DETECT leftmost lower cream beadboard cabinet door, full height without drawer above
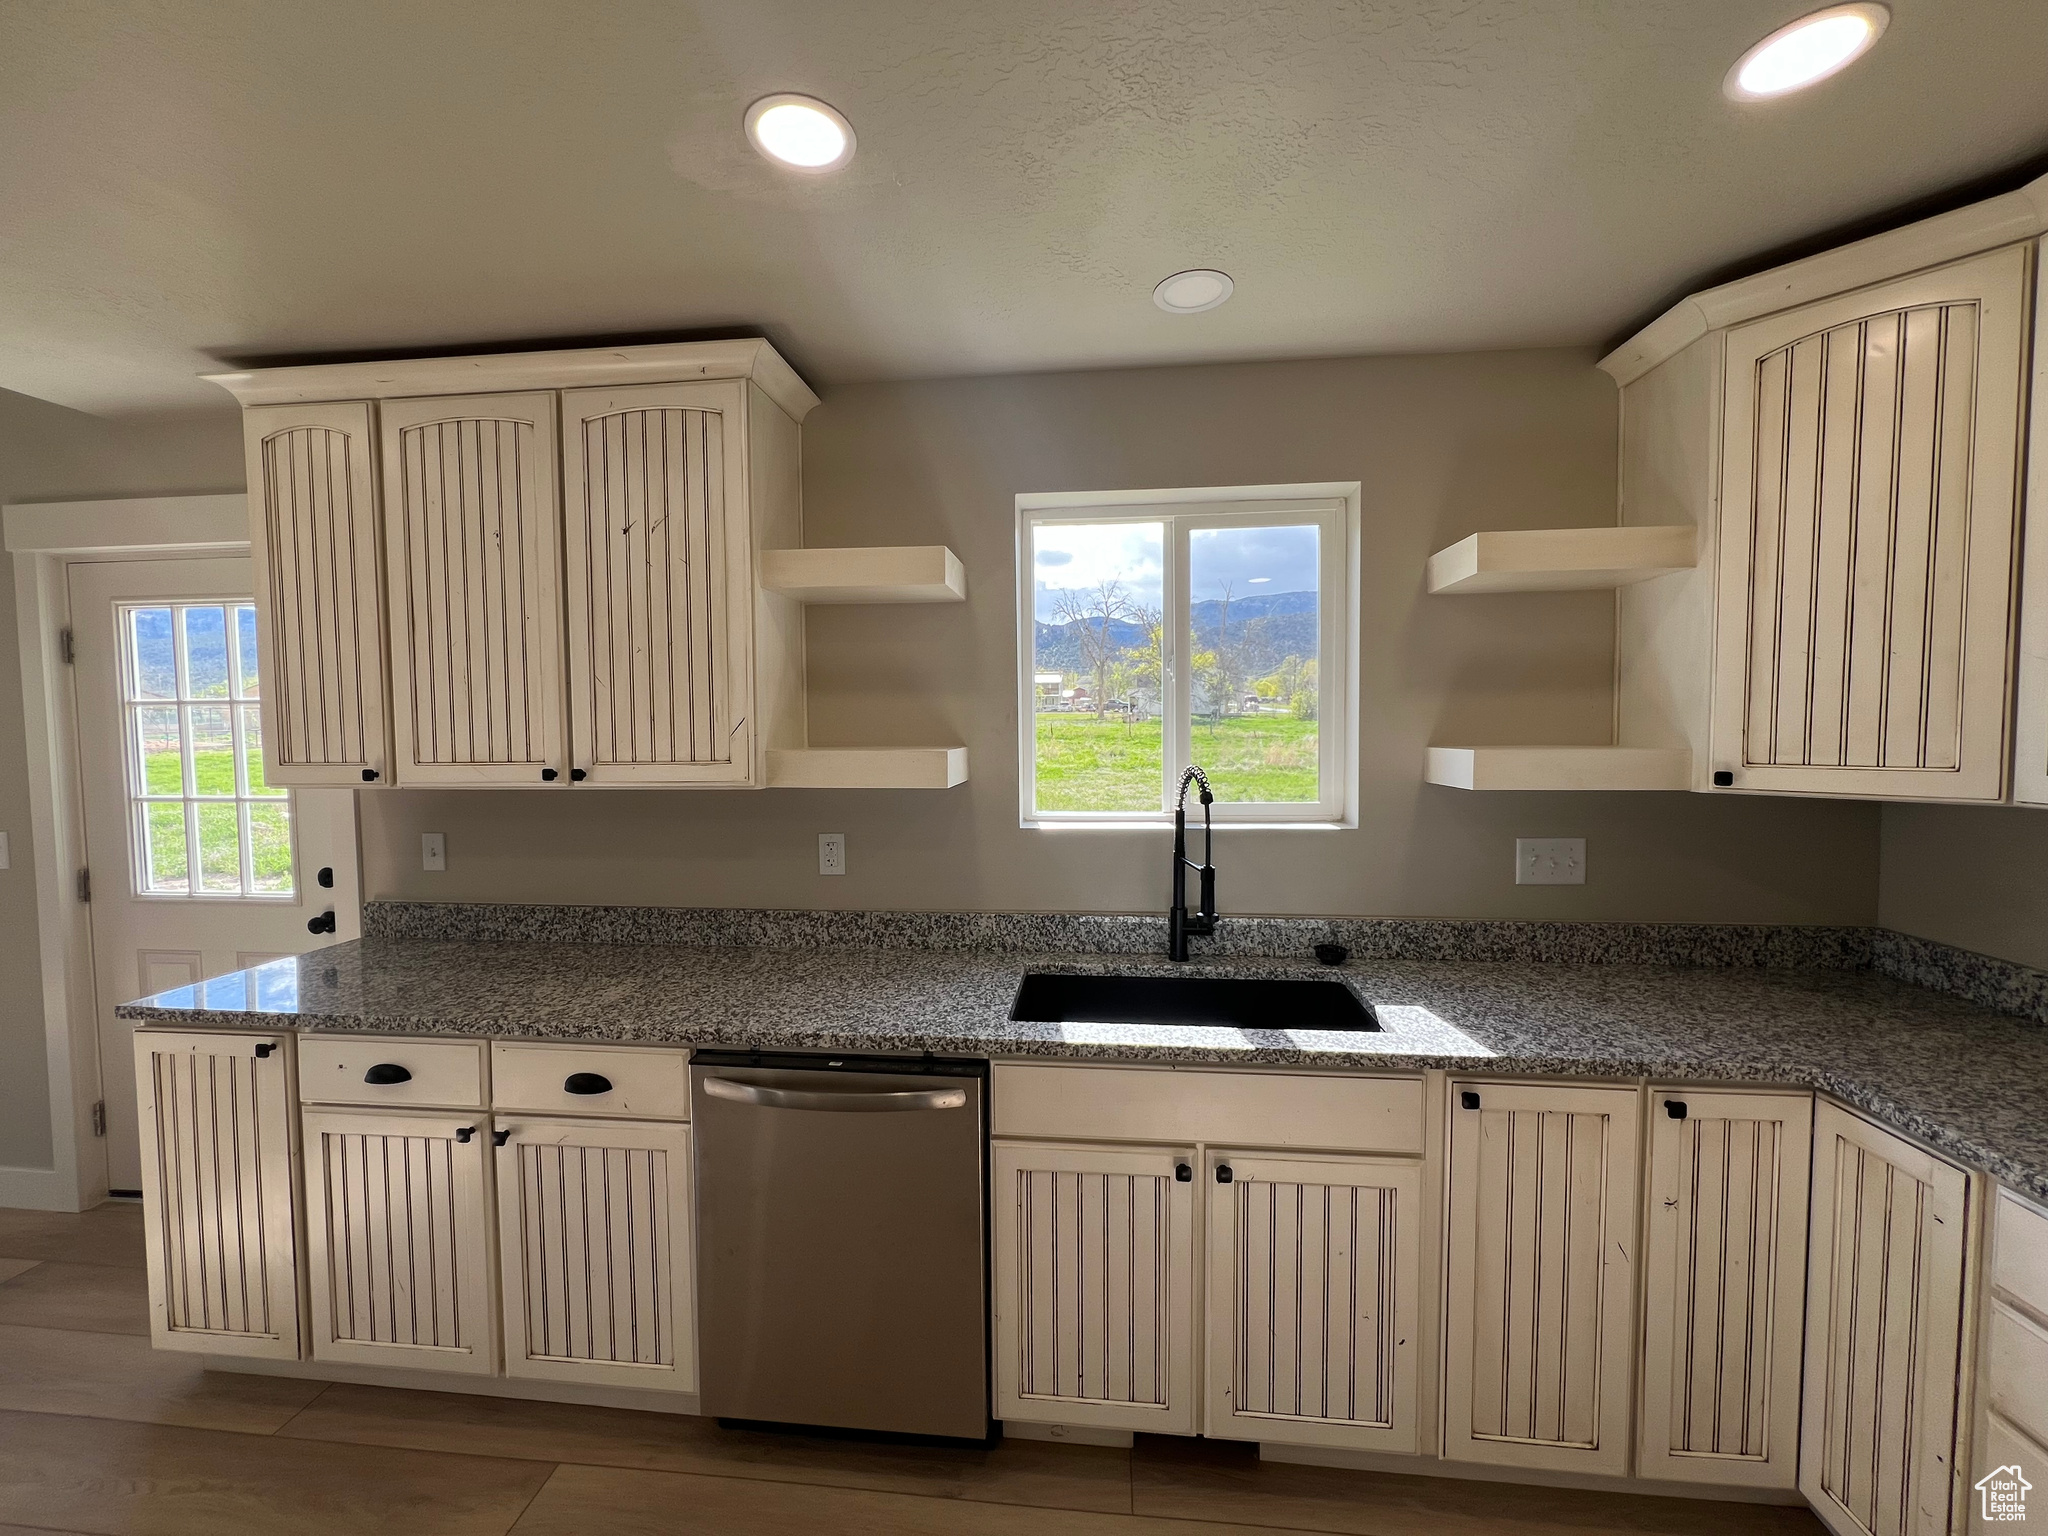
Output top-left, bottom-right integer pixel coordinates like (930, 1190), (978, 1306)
(135, 1030), (299, 1360)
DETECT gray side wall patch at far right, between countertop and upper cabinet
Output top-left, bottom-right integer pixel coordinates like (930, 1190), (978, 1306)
(1878, 805), (2048, 971)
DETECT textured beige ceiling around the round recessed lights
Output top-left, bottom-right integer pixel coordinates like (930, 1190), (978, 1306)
(0, 0), (2048, 412)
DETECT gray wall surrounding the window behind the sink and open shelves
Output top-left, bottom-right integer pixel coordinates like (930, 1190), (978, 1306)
(360, 352), (1878, 924)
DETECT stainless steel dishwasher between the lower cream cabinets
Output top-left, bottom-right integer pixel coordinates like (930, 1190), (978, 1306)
(690, 1051), (989, 1440)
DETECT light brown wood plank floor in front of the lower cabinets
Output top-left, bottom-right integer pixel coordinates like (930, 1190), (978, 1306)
(0, 1206), (1821, 1536)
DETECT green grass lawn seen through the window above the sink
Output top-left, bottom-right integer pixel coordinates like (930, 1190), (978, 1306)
(1038, 715), (1317, 811)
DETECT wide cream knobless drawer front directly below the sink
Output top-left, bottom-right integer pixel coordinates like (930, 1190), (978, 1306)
(989, 1063), (1423, 1153)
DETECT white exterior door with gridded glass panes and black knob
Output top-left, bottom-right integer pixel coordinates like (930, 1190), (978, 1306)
(70, 557), (356, 1190)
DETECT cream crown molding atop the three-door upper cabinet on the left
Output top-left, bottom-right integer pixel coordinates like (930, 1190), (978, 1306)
(201, 340), (817, 422)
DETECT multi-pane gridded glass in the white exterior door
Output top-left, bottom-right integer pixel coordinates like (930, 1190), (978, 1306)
(117, 602), (297, 901)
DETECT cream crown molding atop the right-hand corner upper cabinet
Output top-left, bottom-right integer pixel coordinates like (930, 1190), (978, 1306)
(1599, 165), (2048, 385)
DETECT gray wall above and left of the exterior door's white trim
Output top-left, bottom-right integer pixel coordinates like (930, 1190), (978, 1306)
(0, 391), (242, 1167)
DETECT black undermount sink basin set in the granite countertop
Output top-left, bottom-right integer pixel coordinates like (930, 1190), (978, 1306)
(1010, 971), (1380, 1030)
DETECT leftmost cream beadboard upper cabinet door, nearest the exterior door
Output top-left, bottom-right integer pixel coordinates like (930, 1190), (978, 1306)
(242, 401), (389, 784)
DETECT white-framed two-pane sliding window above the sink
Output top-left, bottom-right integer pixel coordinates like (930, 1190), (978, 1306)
(1018, 485), (1358, 827)
